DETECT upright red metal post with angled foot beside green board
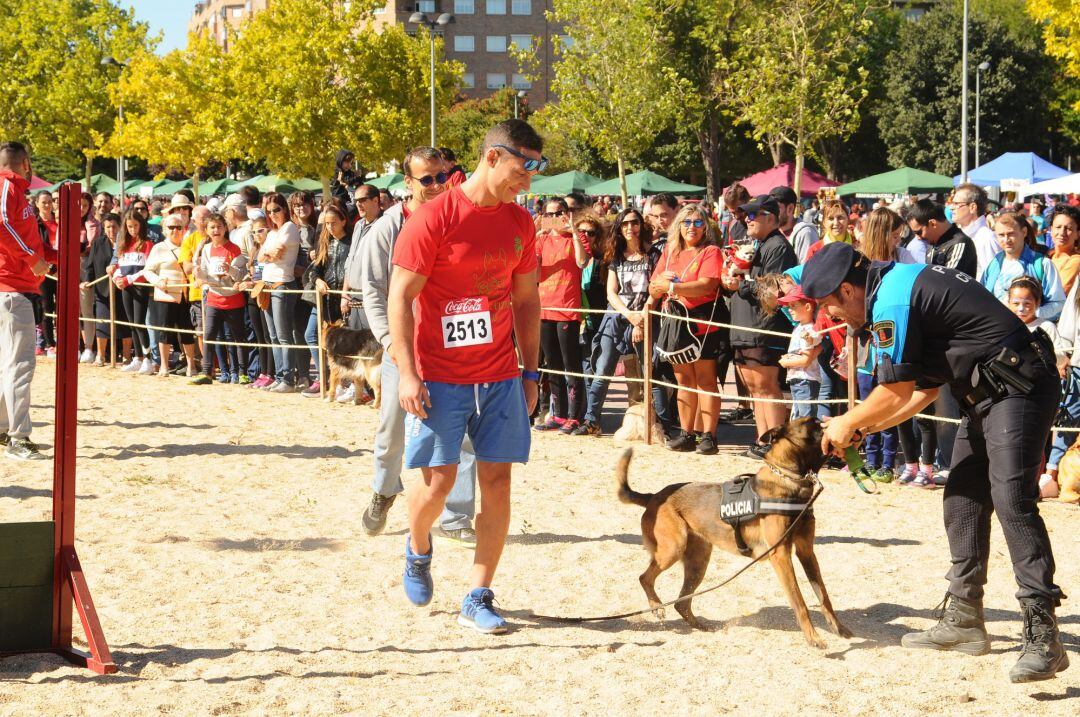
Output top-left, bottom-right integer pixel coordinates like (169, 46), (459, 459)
(45, 184), (117, 675)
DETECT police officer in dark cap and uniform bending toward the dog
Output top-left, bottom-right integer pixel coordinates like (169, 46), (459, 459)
(802, 242), (1069, 682)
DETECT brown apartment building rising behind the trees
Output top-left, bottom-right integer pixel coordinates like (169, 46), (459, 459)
(188, 0), (562, 109)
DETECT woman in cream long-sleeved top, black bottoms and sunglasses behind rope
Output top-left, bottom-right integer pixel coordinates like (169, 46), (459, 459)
(143, 213), (195, 377)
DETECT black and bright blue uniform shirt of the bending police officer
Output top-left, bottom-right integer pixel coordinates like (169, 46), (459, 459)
(866, 262), (1030, 397)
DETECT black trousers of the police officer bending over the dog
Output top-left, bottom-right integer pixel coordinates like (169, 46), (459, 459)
(945, 371), (1062, 604)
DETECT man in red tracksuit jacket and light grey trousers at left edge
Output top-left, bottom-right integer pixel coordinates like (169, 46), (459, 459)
(0, 141), (54, 460)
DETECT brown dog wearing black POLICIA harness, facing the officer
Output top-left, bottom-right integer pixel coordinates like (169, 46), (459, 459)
(617, 418), (851, 648)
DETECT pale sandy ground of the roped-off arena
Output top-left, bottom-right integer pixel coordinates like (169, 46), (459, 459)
(0, 363), (1080, 715)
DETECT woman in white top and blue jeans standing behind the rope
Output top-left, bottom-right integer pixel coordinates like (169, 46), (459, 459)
(257, 192), (309, 393)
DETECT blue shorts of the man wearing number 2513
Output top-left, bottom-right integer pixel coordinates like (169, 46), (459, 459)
(405, 378), (532, 469)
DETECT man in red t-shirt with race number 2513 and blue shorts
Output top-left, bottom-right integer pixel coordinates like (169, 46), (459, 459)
(388, 120), (546, 633)
